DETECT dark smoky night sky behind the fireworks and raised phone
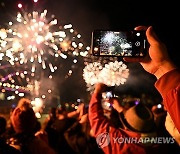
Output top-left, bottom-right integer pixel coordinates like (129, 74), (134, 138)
(0, 0), (180, 104)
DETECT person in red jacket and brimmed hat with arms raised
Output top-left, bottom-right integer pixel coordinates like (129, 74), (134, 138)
(89, 83), (179, 154)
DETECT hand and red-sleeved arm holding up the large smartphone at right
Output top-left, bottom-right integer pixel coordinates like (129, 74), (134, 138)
(124, 26), (180, 143)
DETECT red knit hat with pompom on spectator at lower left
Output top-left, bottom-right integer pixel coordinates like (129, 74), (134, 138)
(11, 106), (37, 133)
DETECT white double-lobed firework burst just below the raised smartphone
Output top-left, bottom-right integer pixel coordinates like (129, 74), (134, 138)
(83, 61), (129, 91)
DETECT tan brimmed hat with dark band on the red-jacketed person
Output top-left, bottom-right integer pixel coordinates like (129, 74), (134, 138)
(120, 103), (155, 133)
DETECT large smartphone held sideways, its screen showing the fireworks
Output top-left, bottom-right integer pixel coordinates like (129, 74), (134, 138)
(91, 30), (148, 57)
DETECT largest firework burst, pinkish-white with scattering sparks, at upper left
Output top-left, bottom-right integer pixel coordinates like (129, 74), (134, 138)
(0, 10), (89, 72)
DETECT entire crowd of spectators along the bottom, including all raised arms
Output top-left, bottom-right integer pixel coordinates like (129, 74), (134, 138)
(0, 26), (180, 154)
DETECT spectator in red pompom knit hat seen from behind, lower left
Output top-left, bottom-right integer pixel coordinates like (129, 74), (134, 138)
(9, 101), (55, 154)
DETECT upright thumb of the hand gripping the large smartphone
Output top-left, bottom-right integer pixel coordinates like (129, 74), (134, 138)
(146, 26), (160, 46)
